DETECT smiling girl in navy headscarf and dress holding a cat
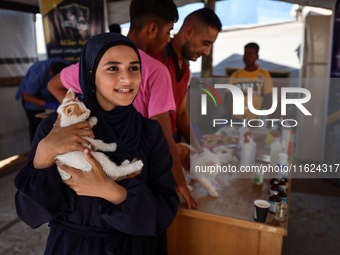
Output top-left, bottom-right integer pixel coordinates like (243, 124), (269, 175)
(15, 33), (179, 255)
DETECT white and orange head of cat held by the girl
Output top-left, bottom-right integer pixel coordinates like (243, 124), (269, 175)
(57, 90), (91, 127)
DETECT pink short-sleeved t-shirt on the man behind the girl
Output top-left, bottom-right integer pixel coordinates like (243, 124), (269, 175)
(60, 50), (176, 118)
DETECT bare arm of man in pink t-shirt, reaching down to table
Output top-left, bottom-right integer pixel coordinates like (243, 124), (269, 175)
(151, 112), (198, 210)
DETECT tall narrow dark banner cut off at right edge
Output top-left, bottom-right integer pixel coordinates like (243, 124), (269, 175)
(323, 0), (340, 164)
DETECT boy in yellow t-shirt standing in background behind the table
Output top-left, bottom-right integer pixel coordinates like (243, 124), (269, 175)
(225, 42), (273, 120)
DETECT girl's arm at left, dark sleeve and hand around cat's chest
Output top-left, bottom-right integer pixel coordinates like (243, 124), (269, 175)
(14, 114), (93, 228)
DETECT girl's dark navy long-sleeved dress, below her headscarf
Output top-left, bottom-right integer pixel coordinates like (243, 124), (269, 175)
(14, 114), (179, 255)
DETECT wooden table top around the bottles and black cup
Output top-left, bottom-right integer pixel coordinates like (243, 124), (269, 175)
(179, 130), (291, 236)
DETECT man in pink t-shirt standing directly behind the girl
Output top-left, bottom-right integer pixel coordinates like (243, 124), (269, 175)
(48, 0), (198, 209)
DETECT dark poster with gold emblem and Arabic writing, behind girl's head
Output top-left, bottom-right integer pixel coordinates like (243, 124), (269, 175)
(40, 0), (105, 63)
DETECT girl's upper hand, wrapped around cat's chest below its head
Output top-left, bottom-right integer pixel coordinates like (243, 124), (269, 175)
(33, 114), (94, 169)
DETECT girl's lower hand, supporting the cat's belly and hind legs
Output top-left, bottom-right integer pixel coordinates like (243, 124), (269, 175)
(56, 149), (127, 204)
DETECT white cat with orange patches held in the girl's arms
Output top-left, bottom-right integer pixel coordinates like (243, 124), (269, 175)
(56, 89), (143, 180)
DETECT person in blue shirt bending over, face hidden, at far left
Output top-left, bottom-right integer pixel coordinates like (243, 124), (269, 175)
(15, 58), (70, 143)
